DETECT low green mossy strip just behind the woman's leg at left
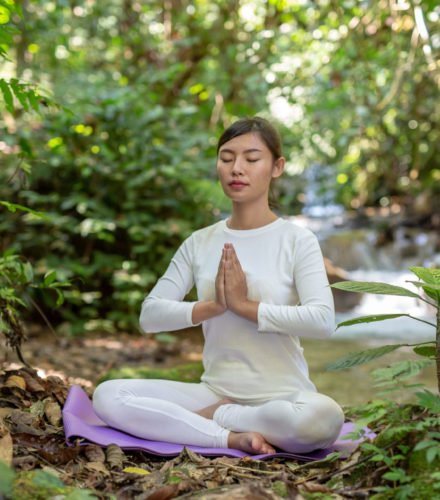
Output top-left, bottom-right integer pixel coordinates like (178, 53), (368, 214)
(98, 361), (203, 383)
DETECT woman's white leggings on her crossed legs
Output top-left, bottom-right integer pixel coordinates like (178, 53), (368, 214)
(93, 379), (344, 453)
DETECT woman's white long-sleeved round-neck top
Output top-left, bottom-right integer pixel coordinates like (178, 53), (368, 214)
(140, 218), (335, 404)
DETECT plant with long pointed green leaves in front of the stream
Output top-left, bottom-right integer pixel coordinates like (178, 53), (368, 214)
(326, 267), (440, 392)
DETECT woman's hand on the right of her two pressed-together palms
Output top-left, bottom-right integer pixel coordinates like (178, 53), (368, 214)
(223, 243), (247, 314)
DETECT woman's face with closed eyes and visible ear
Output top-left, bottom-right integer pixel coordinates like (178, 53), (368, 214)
(217, 132), (285, 203)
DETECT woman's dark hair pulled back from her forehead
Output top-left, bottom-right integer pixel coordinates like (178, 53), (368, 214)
(217, 116), (282, 160)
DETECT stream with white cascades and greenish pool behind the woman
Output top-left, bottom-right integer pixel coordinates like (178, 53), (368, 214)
(289, 187), (440, 404)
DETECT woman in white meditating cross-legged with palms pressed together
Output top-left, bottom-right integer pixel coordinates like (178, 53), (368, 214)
(93, 117), (344, 454)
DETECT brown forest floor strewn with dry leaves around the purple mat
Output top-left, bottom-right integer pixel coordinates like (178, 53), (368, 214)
(0, 332), (438, 500)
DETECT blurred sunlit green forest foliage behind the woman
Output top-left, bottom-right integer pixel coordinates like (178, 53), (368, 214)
(0, 0), (440, 333)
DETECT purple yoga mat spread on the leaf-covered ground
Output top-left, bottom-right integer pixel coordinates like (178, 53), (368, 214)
(63, 385), (375, 461)
